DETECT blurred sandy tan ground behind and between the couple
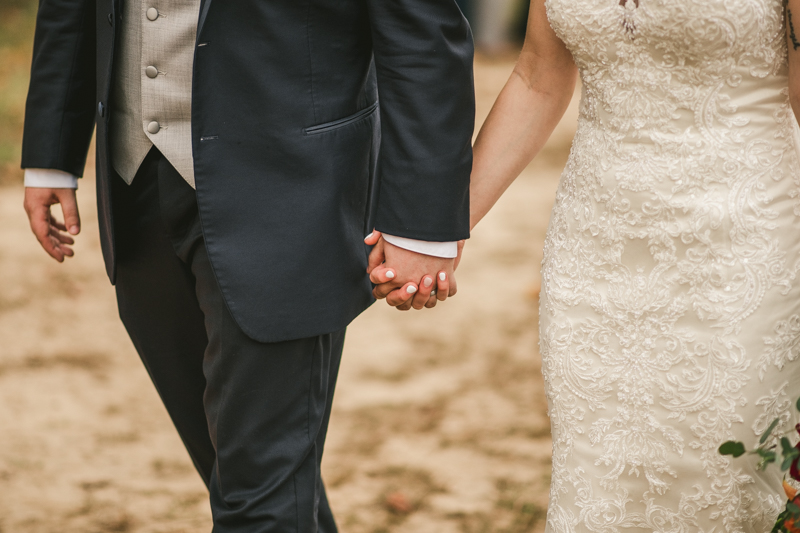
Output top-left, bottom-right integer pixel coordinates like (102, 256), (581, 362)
(0, 60), (576, 533)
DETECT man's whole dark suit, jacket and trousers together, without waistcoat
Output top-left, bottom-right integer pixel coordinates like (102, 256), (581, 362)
(22, 0), (474, 533)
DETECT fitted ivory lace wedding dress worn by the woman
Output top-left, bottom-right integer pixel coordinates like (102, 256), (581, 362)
(540, 0), (800, 533)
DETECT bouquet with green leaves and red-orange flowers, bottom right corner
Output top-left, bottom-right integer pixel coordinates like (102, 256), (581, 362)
(719, 398), (800, 533)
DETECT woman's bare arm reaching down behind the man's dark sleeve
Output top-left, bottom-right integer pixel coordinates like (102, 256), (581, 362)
(470, 0), (576, 227)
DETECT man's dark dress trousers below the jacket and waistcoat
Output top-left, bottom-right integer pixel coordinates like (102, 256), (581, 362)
(111, 148), (344, 533)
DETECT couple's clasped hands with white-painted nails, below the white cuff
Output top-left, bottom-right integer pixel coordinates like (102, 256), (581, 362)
(364, 231), (464, 311)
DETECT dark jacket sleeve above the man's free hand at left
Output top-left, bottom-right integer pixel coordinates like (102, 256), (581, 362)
(22, 0), (97, 176)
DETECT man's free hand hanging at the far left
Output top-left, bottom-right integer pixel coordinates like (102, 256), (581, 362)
(24, 187), (81, 263)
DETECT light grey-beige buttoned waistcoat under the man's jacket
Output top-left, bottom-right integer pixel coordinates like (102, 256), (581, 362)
(109, 0), (200, 187)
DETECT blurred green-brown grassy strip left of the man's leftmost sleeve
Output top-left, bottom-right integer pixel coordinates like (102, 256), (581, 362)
(0, 0), (38, 183)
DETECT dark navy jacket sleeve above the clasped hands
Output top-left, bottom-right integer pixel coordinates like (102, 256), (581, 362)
(367, 0), (475, 241)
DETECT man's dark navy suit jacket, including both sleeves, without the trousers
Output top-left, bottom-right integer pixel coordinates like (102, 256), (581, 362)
(22, 0), (474, 342)
